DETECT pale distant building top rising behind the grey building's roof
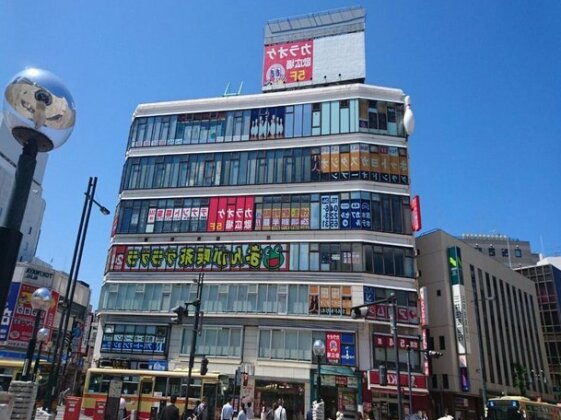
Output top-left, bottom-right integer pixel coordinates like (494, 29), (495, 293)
(459, 234), (540, 269)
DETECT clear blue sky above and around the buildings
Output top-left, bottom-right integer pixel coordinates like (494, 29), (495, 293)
(0, 0), (561, 307)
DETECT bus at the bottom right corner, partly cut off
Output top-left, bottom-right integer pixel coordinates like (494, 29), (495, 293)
(486, 396), (561, 420)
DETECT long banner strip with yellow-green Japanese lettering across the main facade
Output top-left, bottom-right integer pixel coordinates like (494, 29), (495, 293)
(108, 243), (290, 271)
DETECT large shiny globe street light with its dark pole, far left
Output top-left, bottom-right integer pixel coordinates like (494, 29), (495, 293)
(0, 68), (76, 316)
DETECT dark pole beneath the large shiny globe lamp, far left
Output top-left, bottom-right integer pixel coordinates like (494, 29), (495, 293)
(0, 139), (38, 313)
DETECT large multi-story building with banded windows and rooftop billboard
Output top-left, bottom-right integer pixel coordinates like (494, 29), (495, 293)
(94, 9), (422, 419)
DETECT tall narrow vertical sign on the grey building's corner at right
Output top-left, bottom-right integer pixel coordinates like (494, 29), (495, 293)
(448, 246), (470, 392)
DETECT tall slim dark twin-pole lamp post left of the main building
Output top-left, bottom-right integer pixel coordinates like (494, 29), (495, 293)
(43, 177), (110, 412)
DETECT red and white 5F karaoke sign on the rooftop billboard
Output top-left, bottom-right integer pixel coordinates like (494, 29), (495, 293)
(263, 40), (314, 87)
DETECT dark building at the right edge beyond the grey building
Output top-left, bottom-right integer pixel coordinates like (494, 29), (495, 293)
(516, 258), (561, 400)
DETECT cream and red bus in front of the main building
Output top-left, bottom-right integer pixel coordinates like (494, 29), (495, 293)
(82, 368), (228, 420)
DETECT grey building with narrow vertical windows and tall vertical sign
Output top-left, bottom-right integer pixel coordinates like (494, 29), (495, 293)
(416, 230), (553, 420)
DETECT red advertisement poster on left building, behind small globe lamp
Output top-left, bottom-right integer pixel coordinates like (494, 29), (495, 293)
(8, 283), (59, 348)
